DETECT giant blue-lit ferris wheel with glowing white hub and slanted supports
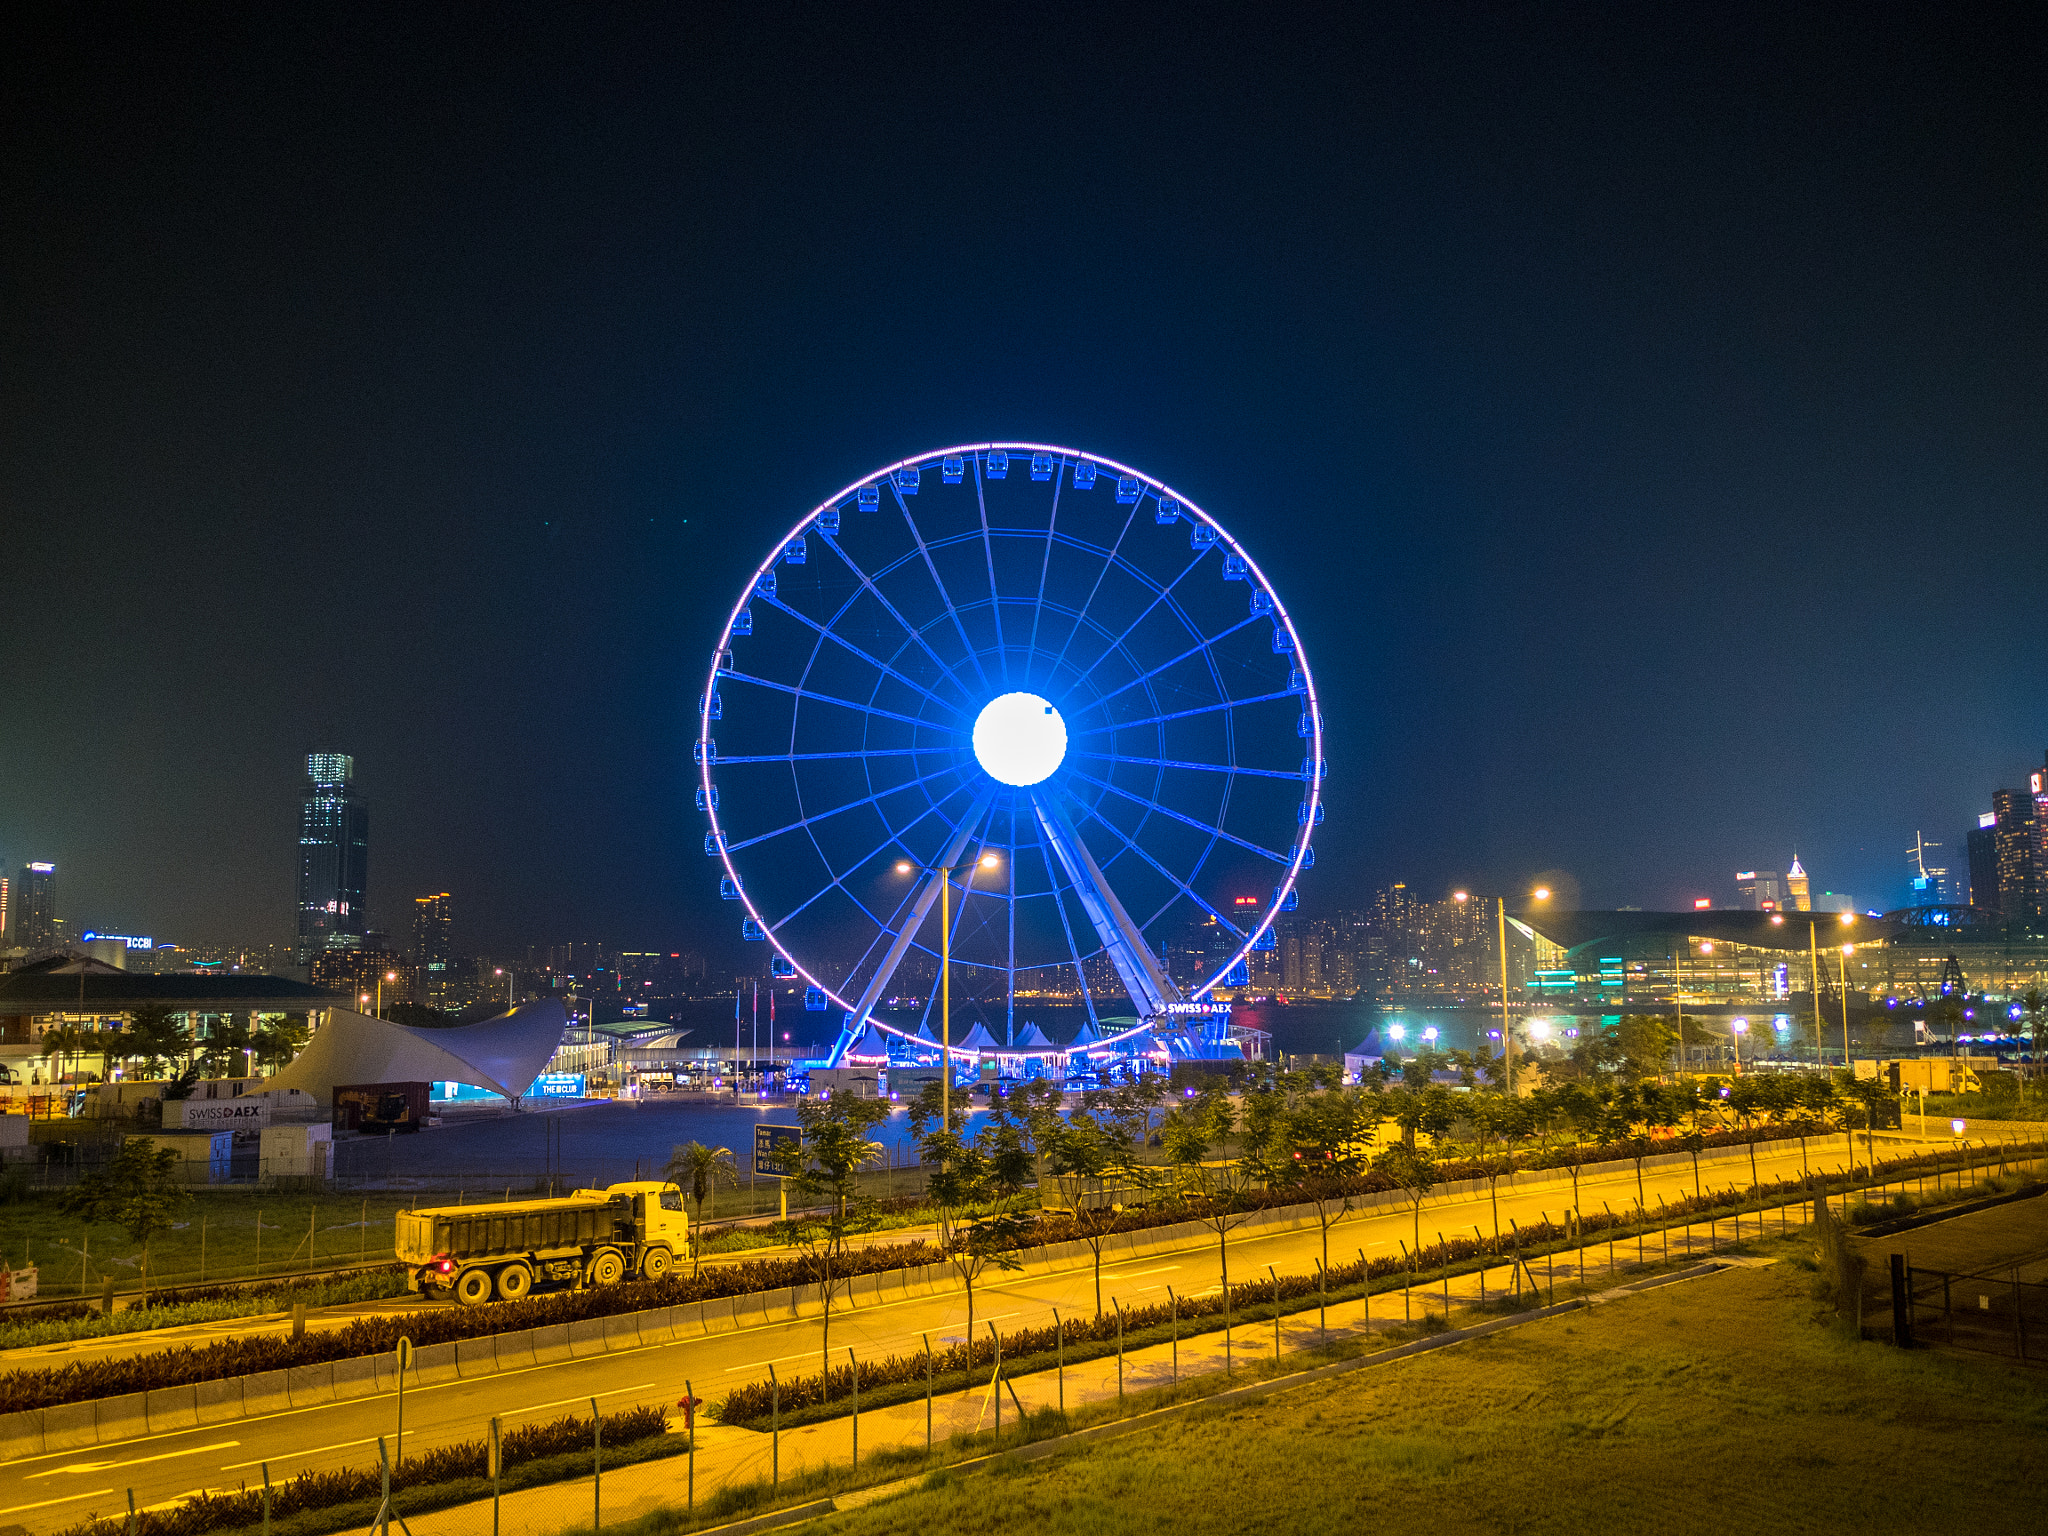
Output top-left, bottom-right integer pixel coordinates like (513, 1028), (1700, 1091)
(694, 442), (1327, 1055)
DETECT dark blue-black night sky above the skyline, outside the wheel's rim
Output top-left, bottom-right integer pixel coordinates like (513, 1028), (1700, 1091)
(0, 4), (2048, 950)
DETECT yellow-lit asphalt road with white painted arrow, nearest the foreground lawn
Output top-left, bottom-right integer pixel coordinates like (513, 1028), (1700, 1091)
(0, 1137), (1966, 1532)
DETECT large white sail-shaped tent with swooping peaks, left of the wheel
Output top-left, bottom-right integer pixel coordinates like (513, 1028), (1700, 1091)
(264, 999), (569, 1108)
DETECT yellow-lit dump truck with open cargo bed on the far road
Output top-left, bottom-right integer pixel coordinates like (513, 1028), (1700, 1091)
(397, 1180), (690, 1307)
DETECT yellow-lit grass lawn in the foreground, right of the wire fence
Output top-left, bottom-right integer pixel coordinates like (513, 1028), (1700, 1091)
(798, 1264), (2048, 1536)
